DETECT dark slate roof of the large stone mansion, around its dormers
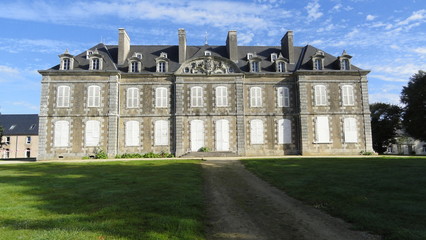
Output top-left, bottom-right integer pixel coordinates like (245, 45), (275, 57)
(49, 43), (361, 72)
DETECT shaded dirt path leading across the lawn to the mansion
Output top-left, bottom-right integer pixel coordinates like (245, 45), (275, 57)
(203, 160), (380, 240)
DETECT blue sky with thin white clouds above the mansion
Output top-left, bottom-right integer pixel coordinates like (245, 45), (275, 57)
(0, 0), (426, 114)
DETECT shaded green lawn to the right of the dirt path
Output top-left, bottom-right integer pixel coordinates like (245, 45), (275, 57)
(243, 157), (426, 240)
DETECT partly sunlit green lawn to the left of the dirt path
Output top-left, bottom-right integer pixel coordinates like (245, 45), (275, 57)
(0, 160), (204, 240)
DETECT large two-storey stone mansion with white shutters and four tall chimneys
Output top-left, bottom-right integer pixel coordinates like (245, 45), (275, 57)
(39, 29), (372, 159)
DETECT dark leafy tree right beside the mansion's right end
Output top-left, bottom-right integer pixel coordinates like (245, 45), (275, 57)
(370, 103), (402, 154)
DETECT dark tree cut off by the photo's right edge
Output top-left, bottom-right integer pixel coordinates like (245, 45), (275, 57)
(401, 71), (426, 141)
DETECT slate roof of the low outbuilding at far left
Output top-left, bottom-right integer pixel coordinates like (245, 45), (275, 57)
(0, 114), (38, 136)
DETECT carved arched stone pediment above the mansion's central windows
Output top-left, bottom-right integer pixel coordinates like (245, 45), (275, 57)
(176, 56), (240, 75)
